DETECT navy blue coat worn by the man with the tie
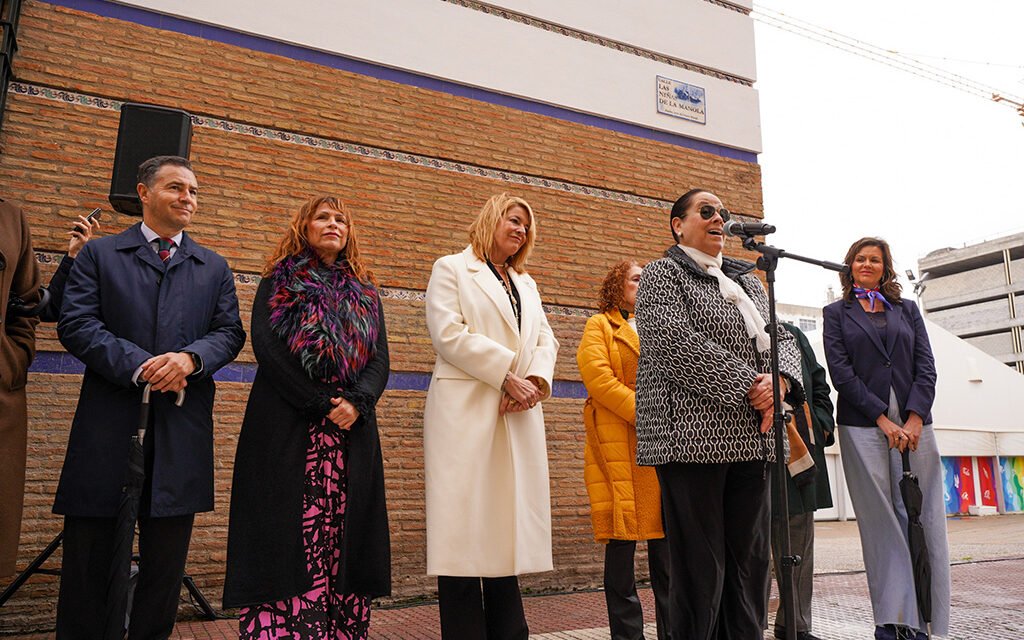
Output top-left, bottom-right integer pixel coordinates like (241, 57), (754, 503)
(53, 224), (246, 517)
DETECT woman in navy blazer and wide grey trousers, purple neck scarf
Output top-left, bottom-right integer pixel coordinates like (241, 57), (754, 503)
(824, 238), (949, 640)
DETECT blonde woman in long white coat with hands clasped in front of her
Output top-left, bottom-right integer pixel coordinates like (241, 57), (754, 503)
(423, 194), (558, 640)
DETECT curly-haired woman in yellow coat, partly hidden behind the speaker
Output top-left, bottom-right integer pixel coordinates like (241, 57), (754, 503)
(577, 261), (669, 640)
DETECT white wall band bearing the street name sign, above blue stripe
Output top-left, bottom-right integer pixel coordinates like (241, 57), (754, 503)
(116, 0), (761, 153)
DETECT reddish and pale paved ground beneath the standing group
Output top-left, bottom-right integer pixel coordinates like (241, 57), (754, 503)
(5, 515), (1024, 640)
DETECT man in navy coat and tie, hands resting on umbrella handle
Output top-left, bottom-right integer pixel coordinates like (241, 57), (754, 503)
(53, 156), (246, 640)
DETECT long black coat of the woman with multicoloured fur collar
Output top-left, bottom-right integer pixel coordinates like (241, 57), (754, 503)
(223, 278), (391, 608)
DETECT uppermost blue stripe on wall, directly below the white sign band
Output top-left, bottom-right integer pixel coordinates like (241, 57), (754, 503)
(37, 0), (758, 164)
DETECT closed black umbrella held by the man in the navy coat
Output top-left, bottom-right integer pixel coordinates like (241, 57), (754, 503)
(103, 384), (185, 640)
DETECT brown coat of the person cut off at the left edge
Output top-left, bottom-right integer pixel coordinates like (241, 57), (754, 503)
(0, 200), (39, 578)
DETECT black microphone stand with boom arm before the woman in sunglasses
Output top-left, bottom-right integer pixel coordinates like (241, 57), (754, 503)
(736, 232), (847, 640)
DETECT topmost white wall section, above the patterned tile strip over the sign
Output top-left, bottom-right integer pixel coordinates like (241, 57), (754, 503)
(488, 0), (757, 82)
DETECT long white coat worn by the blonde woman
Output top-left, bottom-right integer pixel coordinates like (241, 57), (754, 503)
(423, 247), (558, 578)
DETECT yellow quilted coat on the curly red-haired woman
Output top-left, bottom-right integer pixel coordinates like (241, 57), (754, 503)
(577, 309), (665, 542)
